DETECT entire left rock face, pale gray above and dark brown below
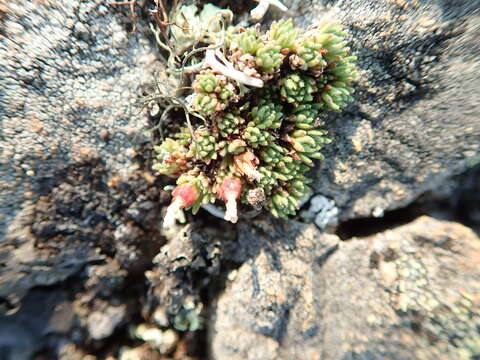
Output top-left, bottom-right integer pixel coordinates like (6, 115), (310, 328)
(0, 0), (168, 360)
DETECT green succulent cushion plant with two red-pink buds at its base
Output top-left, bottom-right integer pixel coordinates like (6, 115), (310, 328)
(154, 19), (357, 221)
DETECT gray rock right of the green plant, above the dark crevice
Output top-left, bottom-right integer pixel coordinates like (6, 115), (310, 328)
(298, 0), (480, 219)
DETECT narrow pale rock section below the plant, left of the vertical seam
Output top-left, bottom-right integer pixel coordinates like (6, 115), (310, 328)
(210, 221), (339, 360)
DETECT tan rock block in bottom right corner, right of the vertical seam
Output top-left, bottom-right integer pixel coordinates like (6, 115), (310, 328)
(321, 217), (480, 359)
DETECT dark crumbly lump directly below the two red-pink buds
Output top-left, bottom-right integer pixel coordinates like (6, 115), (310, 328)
(146, 223), (237, 328)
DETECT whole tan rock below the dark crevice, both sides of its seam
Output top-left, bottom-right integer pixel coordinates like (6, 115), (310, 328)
(210, 217), (480, 360)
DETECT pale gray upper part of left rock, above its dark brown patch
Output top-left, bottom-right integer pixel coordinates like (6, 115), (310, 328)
(0, 0), (156, 241)
